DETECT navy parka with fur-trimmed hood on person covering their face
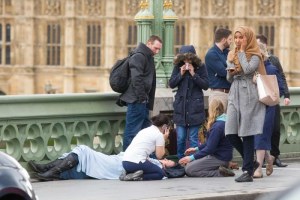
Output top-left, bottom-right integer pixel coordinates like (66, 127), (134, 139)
(169, 45), (208, 126)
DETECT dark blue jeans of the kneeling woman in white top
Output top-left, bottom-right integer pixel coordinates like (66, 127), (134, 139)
(122, 160), (165, 180)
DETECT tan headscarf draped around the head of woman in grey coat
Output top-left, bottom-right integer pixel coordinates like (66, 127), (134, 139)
(231, 26), (266, 75)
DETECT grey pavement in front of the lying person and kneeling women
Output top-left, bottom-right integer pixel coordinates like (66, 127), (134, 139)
(33, 161), (300, 200)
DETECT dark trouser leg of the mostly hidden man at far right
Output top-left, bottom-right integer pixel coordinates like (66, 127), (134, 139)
(271, 105), (280, 158)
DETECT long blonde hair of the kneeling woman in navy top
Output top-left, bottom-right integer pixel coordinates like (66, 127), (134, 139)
(206, 99), (225, 130)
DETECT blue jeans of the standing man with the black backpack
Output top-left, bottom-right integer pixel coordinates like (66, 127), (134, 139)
(123, 103), (152, 151)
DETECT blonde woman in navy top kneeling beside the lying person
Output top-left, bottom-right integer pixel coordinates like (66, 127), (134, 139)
(179, 99), (235, 177)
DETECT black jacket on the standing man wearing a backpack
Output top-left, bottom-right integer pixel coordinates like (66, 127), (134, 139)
(120, 43), (156, 110)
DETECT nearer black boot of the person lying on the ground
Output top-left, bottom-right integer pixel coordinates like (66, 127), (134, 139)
(35, 153), (78, 181)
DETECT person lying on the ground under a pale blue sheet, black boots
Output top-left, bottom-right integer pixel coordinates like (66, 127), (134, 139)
(28, 145), (175, 181)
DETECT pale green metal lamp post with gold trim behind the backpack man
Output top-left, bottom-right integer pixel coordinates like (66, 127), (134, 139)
(135, 0), (177, 88)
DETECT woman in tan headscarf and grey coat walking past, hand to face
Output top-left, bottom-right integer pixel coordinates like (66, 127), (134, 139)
(225, 26), (266, 182)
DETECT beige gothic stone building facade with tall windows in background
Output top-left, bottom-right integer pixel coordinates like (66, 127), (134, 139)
(0, 0), (300, 95)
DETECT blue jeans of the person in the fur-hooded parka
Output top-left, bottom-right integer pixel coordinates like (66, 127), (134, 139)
(176, 125), (200, 159)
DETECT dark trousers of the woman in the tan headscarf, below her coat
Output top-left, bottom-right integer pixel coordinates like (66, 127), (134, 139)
(226, 134), (254, 176)
